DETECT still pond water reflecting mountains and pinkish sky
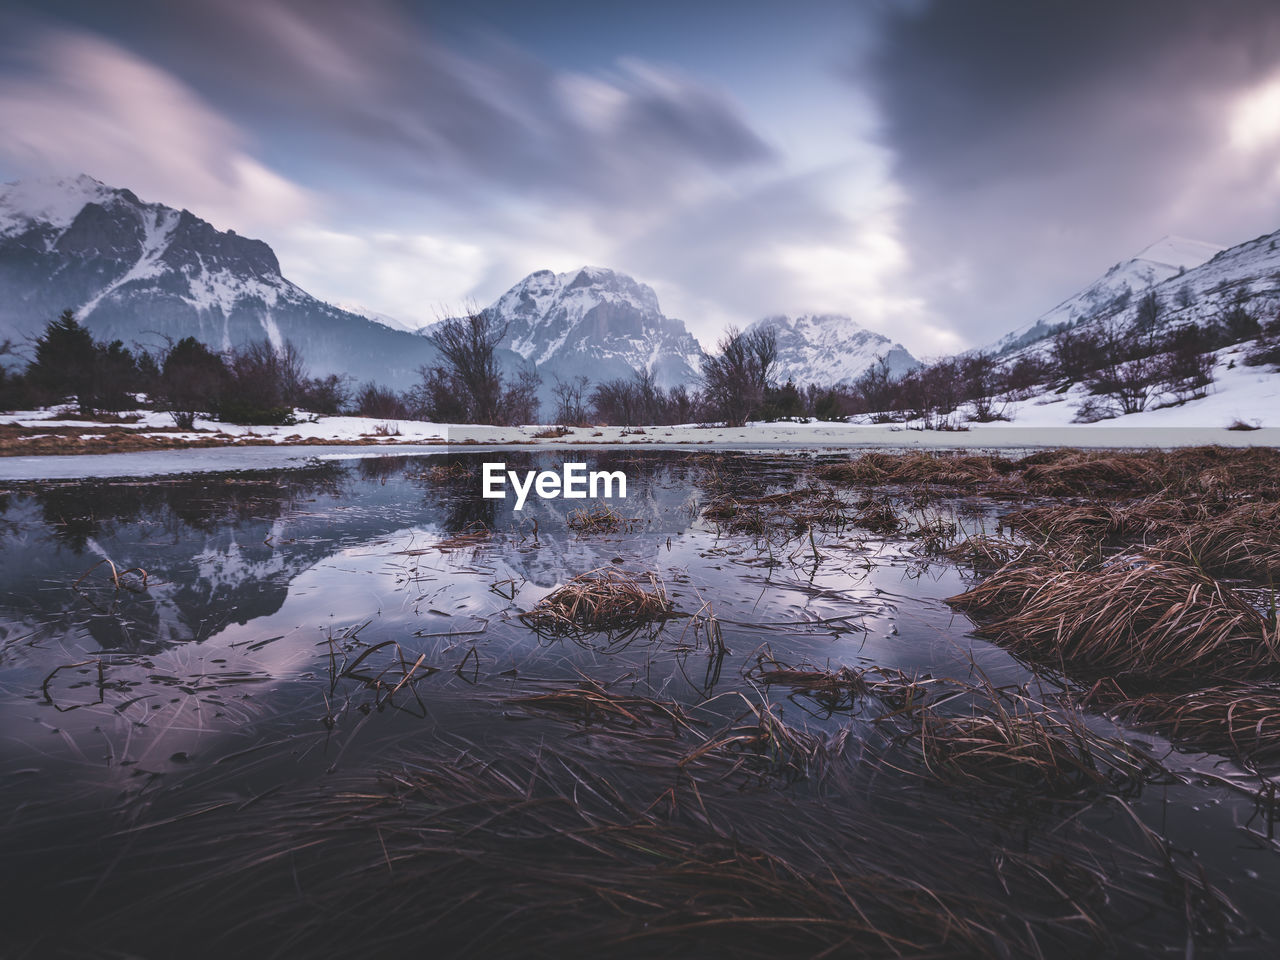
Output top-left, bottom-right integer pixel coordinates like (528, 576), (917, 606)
(0, 452), (1280, 955)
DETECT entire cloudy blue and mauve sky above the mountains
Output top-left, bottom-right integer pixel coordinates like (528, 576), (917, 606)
(0, 0), (1280, 357)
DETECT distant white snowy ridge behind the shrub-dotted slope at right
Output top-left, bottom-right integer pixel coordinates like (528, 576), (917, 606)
(987, 237), (1222, 355)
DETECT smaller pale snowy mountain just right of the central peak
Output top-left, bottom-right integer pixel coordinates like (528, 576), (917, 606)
(748, 314), (920, 387)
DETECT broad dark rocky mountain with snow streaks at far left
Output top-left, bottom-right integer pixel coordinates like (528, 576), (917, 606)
(0, 175), (438, 387)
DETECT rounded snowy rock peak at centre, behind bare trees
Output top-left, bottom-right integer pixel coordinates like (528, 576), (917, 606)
(488, 266), (703, 388)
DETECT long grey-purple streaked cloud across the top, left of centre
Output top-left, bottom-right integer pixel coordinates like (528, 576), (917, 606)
(104, 0), (774, 210)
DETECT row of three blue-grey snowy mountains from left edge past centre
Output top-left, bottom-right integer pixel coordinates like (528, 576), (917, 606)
(0, 175), (916, 399)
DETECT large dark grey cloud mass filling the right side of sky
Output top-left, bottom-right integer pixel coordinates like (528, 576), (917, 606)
(852, 0), (1280, 343)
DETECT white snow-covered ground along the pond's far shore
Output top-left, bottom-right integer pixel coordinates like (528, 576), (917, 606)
(0, 347), (1280, 481)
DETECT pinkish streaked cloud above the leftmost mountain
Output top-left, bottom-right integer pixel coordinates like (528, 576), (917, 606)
(0, 31), (312, 230)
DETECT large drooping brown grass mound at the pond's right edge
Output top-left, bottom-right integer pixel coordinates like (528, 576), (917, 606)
(947, 561), (1280, 680)
